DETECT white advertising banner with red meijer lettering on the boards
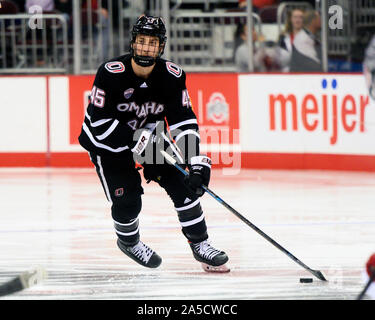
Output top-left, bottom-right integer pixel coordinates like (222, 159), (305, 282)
(239, 74), (375, 155)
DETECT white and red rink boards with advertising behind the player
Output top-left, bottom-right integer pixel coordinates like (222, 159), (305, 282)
(0, 73), (375, 171)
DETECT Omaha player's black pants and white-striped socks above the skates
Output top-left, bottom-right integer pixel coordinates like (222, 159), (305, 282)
(90, 153), (208, 245)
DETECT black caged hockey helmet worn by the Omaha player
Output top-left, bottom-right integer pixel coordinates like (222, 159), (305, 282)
(130, 15), (167, 67)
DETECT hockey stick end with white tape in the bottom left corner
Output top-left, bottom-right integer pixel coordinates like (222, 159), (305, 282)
(0, 267), (47, 296)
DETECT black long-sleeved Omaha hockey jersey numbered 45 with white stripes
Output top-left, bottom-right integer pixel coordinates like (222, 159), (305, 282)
(79, 54), (200, 161)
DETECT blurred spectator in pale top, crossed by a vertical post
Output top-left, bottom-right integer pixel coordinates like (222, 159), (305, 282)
(234, 25), (280, 72)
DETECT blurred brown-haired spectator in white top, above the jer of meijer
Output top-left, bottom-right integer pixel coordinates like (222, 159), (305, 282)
(290, 10), (323, 72)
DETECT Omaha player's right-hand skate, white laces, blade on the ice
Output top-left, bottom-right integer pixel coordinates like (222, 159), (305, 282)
(189, 240), (230, 273)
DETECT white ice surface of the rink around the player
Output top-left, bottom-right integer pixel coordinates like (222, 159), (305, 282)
(0, 168), (375, 300)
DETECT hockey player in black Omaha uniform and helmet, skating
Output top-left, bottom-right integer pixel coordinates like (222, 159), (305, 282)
(79, 15), (229, 272)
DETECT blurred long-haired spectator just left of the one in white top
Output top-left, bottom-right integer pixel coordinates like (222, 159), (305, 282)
(278, 9), (304, 72)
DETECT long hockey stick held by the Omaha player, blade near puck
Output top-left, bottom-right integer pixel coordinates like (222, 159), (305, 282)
(160, 148), (327, 281)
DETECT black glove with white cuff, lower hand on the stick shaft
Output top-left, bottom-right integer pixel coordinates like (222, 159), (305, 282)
(185, 155), (211, 197)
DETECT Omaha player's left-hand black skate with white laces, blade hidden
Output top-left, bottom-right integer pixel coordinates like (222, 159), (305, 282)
(117, 239), (162, 268)
